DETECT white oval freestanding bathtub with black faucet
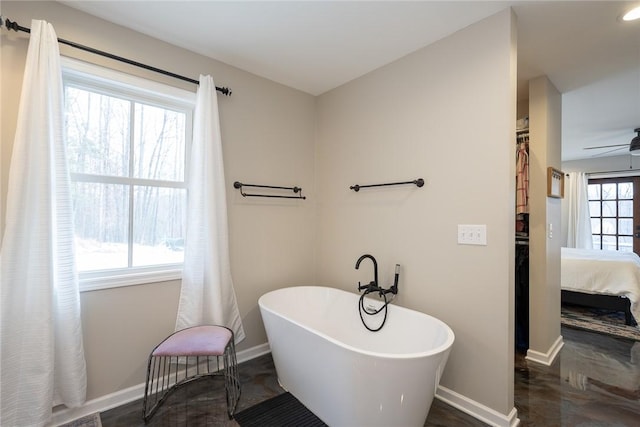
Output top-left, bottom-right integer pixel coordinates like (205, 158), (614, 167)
(258, 286), (454, 427)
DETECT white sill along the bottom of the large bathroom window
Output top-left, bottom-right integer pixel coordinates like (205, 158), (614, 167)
(79, 266), (182, 292)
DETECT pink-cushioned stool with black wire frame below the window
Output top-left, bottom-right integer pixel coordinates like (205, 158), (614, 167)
(142, 325), (240, 422)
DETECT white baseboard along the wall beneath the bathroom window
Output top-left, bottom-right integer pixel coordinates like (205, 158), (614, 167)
(47, 343), (271, 426)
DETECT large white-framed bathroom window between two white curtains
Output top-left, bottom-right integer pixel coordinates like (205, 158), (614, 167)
(63, 60), (194, 290)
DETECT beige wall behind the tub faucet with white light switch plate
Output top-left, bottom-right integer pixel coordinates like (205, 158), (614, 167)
(316, 10), (516, 415)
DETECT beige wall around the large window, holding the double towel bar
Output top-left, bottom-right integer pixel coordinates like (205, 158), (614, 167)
(0, 1), (315, 399)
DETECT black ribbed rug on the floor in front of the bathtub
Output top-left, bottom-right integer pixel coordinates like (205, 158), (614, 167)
(234, 393), (327, 427)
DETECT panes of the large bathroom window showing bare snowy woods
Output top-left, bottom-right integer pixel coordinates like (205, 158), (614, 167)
(65, 85), (187, 271)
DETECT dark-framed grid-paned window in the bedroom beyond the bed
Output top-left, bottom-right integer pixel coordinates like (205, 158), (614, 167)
(588, 177), (640, 252)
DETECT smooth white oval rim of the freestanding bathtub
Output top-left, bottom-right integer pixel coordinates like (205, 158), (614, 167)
(258, 285), (455, 359)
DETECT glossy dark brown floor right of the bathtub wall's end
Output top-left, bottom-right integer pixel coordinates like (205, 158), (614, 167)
(515, 327), (640, 427)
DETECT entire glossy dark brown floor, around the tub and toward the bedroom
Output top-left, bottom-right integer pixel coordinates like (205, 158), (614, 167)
(101, 327), (640, 427)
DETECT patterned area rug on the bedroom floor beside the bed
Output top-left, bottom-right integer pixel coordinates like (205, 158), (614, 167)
(561, 305), (640, 341)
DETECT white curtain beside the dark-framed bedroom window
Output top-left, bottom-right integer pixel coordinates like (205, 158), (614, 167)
(567, 172), (593, 249)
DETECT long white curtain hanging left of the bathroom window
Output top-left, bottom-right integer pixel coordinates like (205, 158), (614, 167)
(0, 20), (86, 426)
